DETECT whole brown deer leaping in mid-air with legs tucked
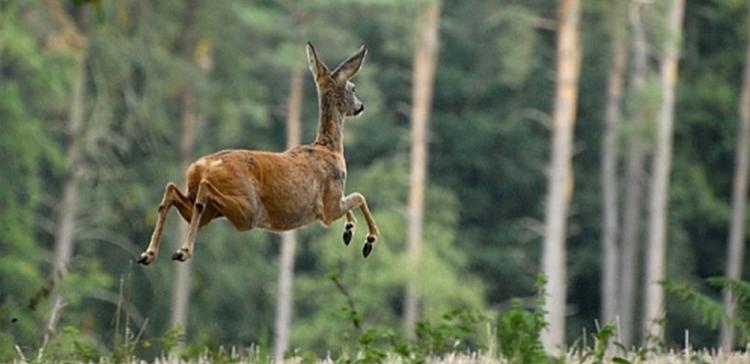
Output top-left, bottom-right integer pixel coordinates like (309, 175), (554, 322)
(138, 42), (379, 265)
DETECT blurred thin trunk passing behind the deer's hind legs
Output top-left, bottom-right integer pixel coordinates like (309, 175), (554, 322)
(170, 86), (198, 329)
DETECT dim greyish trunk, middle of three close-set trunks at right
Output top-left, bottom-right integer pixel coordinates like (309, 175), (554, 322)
(618, 1), (648, 347)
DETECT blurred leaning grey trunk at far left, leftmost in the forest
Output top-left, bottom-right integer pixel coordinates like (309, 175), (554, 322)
(46, 49), (88, 335)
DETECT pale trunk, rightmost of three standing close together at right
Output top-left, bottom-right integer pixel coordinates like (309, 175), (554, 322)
(644, 0), (685, 340)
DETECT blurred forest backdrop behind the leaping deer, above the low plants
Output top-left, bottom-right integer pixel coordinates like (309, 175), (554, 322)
(0, 0), (750, 360)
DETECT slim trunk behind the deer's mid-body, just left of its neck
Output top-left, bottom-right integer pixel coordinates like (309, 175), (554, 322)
(273, 67), (303, 362)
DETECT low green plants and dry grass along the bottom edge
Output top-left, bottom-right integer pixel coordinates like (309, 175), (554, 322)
(12, 275), (750, 364)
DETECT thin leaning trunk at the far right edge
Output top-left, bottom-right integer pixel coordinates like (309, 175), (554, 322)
(719, 7), (750, 350)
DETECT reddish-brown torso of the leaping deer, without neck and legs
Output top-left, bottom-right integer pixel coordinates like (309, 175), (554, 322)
(187, 145), (346, 231)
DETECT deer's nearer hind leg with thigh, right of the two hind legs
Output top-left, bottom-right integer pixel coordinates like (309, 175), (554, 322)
(172, 179), (254, 262)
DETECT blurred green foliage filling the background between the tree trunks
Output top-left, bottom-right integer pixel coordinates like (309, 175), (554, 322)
(0, 0), (750, 356)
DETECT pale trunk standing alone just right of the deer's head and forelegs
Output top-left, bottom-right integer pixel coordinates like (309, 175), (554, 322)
(404, 0), (440, 337)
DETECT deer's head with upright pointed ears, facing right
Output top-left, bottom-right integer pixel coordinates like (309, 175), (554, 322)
(307, 42), (367, 116)
